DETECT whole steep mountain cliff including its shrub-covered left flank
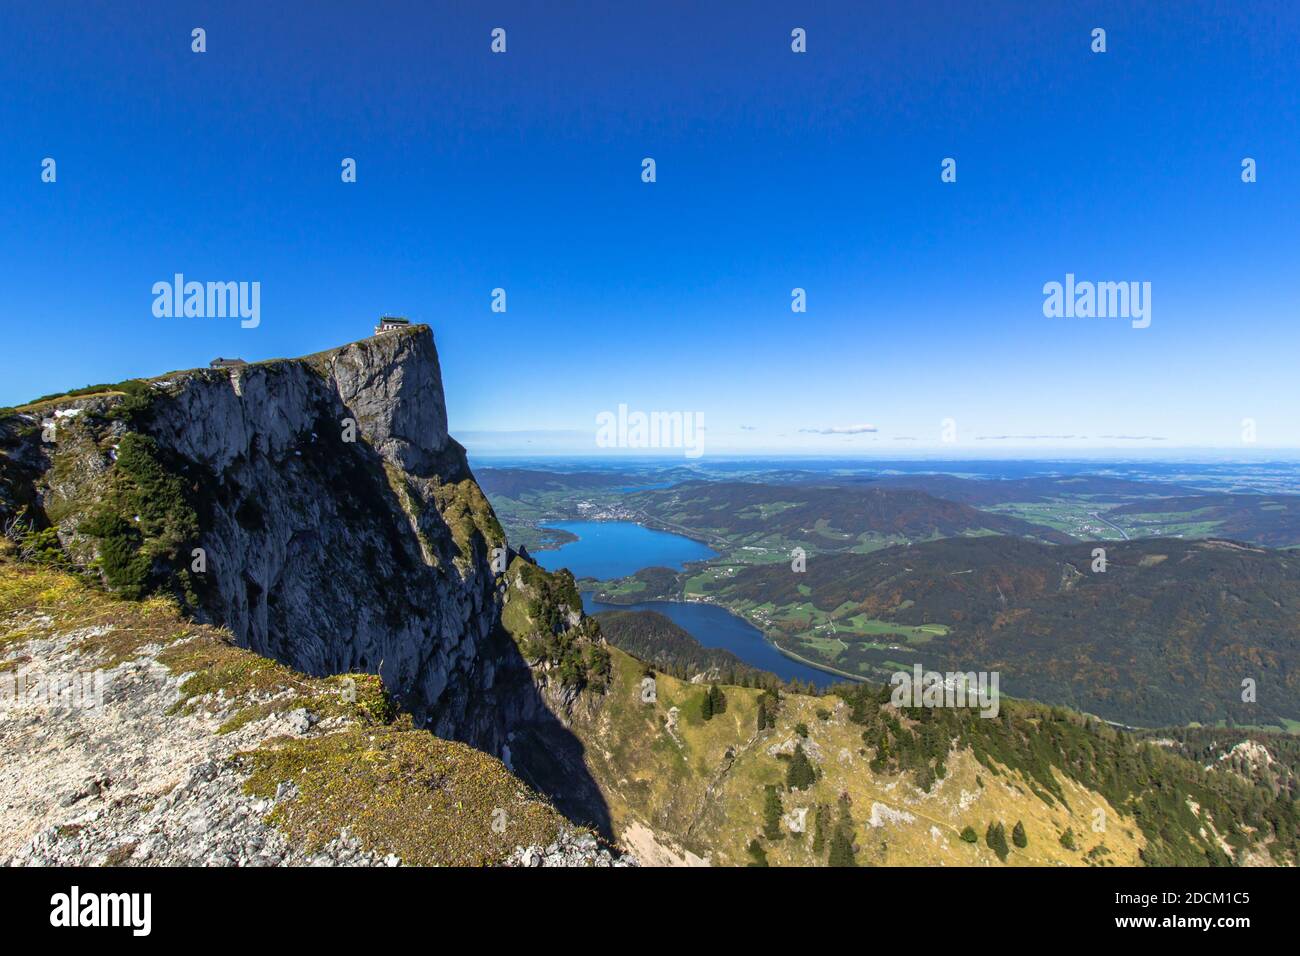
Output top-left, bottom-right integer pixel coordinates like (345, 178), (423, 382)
(0, 326), (551, 752)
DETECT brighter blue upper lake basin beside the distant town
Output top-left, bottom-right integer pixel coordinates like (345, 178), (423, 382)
(533, 522), (718, 580)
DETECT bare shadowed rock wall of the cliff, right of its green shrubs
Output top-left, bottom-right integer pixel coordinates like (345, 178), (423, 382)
(148, 329), (504, 734)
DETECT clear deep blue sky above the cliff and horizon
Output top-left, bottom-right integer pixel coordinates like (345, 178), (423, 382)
(0, 0), (1300, 455)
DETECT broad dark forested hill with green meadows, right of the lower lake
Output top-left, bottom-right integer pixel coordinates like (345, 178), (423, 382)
(705, 537), (1300, 727)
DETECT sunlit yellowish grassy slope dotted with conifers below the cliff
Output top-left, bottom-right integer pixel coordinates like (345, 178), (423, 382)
(575, 649), (1144, 865)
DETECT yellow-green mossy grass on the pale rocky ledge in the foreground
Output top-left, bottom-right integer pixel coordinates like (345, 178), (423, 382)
(0, 554), (566, 865)
